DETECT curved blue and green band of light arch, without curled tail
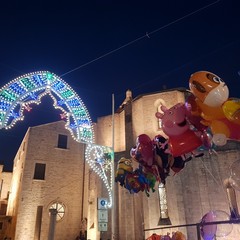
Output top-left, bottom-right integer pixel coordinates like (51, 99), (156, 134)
(0, 71), (94, 143)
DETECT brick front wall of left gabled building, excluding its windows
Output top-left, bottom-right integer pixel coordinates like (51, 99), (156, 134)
(9, 122), (87, 240)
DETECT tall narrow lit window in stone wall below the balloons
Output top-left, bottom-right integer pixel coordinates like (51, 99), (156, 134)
(158, 183), (171, 225)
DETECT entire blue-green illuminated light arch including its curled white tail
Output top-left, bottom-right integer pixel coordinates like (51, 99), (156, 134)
(0, 71), (113, 207)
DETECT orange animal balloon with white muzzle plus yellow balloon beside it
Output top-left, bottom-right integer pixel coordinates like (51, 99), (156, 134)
(189, 71), (240, 146)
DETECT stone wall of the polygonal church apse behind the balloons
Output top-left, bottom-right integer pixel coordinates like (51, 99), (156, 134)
(110, 90), (240, 240)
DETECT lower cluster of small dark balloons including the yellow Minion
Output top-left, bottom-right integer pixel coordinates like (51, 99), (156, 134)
(115, 134), (192, 196)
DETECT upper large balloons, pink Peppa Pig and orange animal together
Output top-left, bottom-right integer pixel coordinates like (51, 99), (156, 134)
(155, 71), (240, 154)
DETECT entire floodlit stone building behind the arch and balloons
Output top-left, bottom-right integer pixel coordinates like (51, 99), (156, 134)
(0, 89), (240, 240)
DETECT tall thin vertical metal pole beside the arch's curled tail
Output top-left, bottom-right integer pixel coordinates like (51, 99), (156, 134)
(111, 94), (116, 240)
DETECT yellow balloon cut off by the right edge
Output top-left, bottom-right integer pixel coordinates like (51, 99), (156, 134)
(222, 98), (240, 124)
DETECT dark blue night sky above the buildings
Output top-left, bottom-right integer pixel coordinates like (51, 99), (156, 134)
(0, 0), (240, 170)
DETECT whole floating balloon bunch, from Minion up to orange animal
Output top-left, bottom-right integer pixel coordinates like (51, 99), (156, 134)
(115, 71), (240, 196)
